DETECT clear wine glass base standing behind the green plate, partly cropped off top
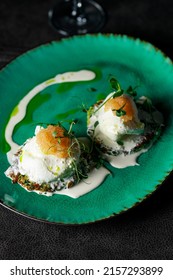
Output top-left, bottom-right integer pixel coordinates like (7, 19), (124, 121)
(48, 0), (106, 36)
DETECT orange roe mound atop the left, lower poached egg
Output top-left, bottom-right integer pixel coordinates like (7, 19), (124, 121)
(36, 125), (71, 158)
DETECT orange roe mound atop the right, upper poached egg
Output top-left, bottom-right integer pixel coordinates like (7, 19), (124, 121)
(104, 95), (136, 122)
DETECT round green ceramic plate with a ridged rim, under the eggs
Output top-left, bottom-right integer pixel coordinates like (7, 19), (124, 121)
(0, 35), (173, 224)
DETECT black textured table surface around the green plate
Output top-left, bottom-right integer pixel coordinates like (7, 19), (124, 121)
(0, 0), (173, 260)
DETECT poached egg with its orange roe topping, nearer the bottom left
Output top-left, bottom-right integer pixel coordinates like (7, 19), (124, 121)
(8, 125), (80, 184)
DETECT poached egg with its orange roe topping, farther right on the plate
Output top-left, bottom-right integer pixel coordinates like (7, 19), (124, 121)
(88, 93), (144, 151)
